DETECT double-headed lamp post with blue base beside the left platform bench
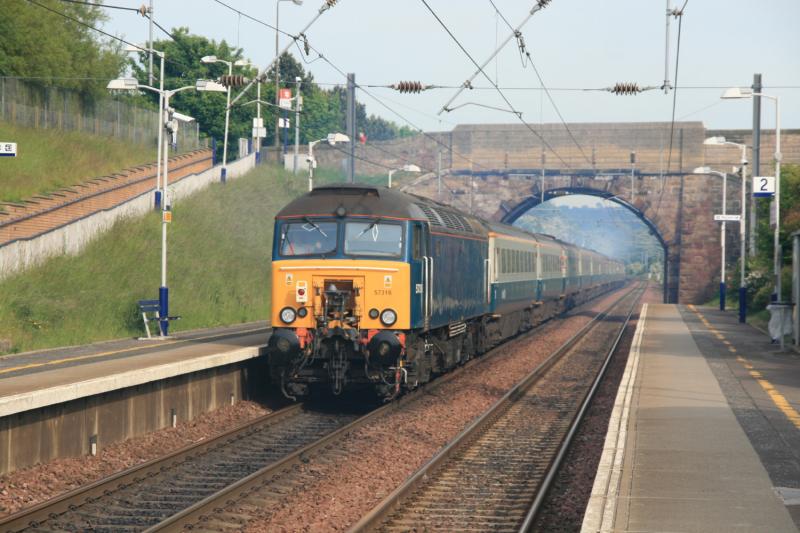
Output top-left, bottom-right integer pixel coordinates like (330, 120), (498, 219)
(106, 76), (224, 338)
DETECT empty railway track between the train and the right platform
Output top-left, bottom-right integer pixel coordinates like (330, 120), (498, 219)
(351, 280), (644, 533)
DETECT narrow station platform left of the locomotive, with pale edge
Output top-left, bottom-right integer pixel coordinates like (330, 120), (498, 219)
(0, 322), (270, 418)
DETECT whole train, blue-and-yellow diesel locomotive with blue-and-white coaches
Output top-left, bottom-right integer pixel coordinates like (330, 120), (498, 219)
(268, 185), (625, 399)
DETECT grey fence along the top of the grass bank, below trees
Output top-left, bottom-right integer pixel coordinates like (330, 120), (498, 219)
(0, 77), (207, 152)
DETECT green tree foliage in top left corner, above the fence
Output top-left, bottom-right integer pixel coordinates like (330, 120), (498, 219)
(0, 0), (126, 102)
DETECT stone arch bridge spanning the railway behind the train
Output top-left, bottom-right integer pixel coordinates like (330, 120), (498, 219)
(318, 122), (800, 303)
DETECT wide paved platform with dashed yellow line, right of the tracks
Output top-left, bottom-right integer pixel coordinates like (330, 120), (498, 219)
(582, 304), (800, 532)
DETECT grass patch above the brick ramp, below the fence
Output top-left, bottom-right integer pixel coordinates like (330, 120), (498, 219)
(0, 122), (156, 202)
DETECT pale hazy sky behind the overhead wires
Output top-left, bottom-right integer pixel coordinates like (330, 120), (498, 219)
(95, 0), (800, 131)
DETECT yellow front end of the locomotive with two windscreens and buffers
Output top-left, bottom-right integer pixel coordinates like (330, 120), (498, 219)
(269, 186), (412, 399)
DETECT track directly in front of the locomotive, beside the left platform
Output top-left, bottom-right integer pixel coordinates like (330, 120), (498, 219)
(0, 404), (359, 532)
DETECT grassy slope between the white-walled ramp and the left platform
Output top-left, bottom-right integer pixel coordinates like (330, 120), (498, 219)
(0, 165), (385, 351)
